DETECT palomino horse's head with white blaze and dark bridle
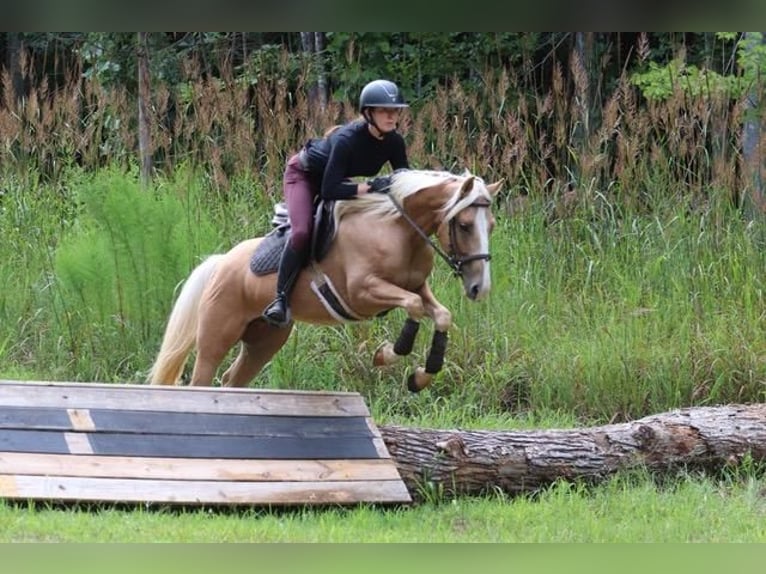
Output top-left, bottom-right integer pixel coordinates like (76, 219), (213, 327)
(437, 175), (503, 300)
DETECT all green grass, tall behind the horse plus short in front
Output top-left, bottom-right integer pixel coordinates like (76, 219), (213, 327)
(0, 168), (766, 542)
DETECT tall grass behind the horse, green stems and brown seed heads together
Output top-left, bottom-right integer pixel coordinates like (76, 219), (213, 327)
(0, 48), (766, 426)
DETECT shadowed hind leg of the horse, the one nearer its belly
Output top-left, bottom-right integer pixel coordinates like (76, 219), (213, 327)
(221, 319), (292, 387)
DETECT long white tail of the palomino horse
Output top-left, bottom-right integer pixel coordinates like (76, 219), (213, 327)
(147, 254), (223, 385)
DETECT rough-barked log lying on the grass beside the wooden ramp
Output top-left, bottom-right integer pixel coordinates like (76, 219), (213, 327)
(379, 404), (766, 498)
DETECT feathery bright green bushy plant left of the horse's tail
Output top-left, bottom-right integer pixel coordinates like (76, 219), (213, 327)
(54, 172), (216, 378)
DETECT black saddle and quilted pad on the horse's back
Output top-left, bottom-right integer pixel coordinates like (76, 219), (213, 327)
(250, 198), (335, 275)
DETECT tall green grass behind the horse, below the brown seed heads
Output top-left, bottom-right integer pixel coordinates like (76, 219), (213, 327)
(0, 166), (766, 424)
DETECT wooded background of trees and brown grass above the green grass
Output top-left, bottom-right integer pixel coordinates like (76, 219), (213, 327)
(0, 32), (764, 212)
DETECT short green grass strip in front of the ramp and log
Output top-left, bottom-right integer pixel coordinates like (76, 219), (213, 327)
(0, 473), (766, 542)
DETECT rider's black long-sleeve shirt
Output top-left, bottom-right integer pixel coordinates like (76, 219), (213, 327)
(306, 121), (409, 199)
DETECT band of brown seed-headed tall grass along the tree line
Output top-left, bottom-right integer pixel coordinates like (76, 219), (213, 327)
(0, 52), (744, 207)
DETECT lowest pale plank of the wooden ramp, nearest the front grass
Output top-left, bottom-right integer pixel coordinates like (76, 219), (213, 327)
(0, 475), (411, 505)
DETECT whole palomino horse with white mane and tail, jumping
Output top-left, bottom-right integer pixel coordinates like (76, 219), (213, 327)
(149, 170), (502, 392)
